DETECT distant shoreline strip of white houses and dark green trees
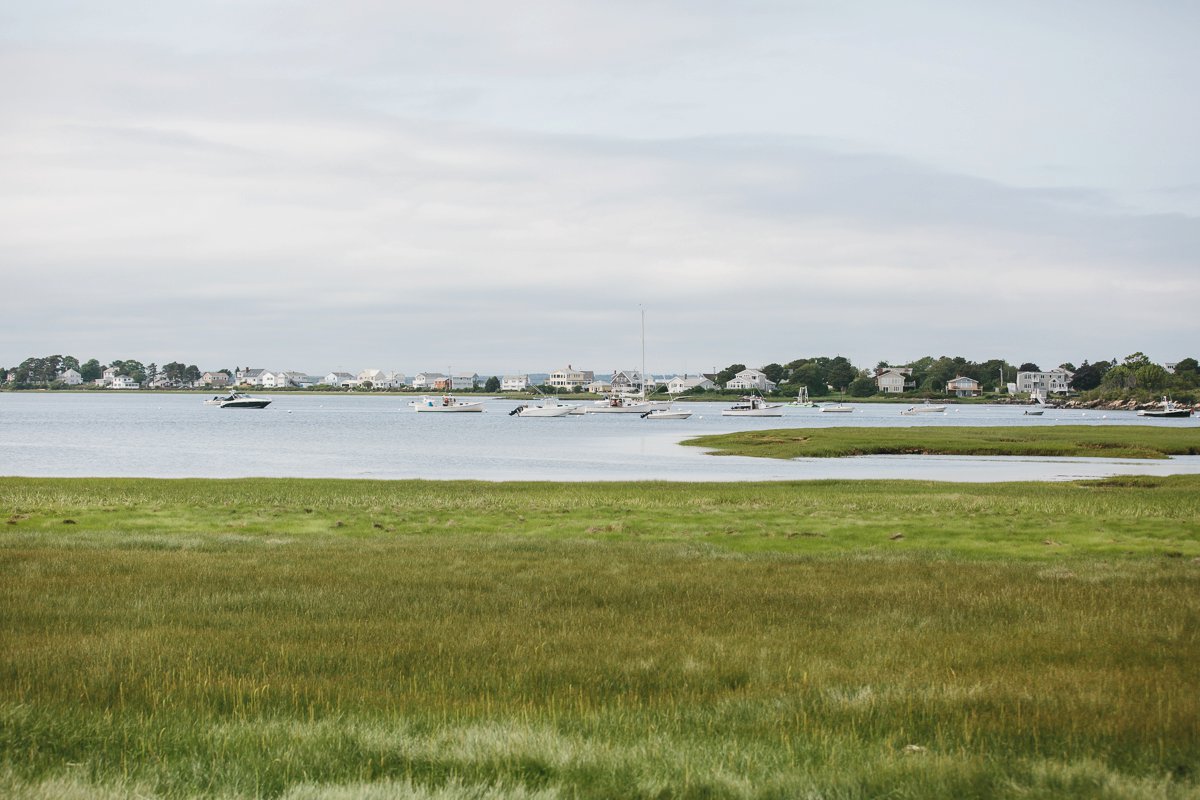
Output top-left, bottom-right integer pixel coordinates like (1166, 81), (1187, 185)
(0, 353), (1200, 402)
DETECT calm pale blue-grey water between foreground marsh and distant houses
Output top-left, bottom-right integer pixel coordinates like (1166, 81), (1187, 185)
(0, 392), (1200, 481)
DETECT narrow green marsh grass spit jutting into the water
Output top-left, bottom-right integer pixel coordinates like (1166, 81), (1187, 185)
(684, 425), (1200, 458)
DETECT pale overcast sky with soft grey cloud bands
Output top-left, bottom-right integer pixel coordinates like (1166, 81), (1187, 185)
(0, 0), (1200, 374)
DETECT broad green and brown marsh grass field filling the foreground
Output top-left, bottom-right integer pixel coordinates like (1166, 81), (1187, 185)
(0, 476), (1200, 799)
